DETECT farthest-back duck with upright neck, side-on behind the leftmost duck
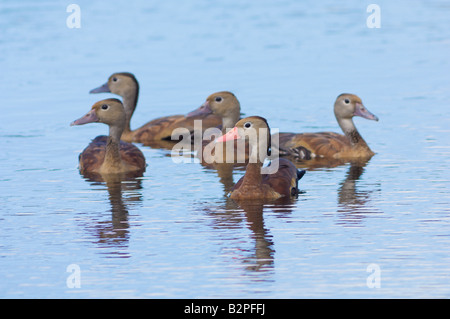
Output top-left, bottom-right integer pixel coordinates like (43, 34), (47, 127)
(89, 72), (221, 144)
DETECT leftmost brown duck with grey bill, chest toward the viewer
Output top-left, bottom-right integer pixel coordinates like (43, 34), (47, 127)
(71, 99), (146, 176)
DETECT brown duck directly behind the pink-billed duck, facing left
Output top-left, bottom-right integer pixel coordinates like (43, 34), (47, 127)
(186, 91), (249, 164)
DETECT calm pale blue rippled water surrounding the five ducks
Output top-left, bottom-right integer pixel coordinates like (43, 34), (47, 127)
(0, 0), (450, 298)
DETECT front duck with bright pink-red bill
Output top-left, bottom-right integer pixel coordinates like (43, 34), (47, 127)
(217, 116), (306, 201)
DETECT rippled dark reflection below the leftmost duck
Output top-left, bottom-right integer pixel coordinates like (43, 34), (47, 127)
(84, 174), (142, 257)
